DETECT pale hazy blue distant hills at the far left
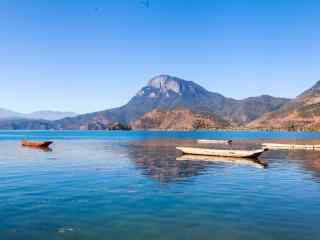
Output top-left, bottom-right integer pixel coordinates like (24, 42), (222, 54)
(0, 108), (78, 121)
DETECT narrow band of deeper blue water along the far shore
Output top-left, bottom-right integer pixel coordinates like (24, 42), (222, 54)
(0, 131), (320, 140)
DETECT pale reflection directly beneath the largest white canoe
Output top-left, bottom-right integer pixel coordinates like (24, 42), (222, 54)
(176, 155), (268, 168)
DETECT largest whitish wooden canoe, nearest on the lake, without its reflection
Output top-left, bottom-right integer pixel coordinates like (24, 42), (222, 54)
(177, 147), (267, 158)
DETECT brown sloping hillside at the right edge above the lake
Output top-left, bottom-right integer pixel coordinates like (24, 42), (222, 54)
(248, 81), (320, 130)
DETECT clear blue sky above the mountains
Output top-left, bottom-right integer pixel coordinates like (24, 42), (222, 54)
(0, 0), (320, 113)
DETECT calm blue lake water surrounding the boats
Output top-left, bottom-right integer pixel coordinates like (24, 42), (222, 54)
(0, 131), (320, 240)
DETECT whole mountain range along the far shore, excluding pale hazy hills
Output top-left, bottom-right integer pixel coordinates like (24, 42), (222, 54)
(0, 75), (320, 130)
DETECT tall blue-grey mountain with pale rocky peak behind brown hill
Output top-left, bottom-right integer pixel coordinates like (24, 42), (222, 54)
(55, 75), (289, 129)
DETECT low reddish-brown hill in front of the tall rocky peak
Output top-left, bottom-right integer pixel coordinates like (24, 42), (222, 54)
(131, 108), (230, 130)
